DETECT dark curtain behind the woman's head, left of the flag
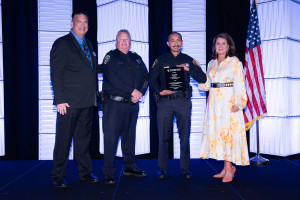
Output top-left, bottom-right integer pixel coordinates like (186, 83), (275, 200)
(206, 0), (250, 64)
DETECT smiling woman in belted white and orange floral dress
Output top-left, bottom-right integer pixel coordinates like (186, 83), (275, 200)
(199, 33), (249, 182)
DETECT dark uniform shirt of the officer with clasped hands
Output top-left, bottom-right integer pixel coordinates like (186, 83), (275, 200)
(102, 49), (148, 97)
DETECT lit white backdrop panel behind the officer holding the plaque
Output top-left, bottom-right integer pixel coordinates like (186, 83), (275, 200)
(172, 0), (206, 158)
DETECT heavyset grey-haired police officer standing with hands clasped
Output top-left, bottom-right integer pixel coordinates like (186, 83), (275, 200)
(101, 29), (148, 184)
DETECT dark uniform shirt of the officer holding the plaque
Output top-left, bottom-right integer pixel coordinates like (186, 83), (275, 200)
(149, 52), (206, 94)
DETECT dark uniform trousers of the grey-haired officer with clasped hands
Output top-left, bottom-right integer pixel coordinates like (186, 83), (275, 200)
(102, 100), (139, 178)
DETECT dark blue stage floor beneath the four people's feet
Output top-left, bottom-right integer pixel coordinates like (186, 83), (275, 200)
(0, 158), (300, 200)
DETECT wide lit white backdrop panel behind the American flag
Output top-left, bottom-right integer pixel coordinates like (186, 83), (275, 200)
(250, 0), (300, 156)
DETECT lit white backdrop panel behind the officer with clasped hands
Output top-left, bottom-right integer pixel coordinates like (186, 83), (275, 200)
(97, 0), (150, 156)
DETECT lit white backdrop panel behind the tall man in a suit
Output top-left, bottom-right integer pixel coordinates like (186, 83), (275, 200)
(38, 0), (73, 160)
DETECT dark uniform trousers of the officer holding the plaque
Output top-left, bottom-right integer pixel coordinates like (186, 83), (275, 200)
(157, 98), (192, 171)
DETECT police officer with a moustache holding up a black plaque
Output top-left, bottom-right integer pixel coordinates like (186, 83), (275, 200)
(149, 32), (206, 179)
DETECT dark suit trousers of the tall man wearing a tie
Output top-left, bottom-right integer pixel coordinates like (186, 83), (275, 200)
(52, 107), (93, 179)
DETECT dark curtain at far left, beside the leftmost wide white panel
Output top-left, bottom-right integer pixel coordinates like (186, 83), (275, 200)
(0, 0), (39, 160)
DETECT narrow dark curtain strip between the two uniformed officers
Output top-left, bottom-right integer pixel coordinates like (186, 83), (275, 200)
(144, 0), (173, 158)
